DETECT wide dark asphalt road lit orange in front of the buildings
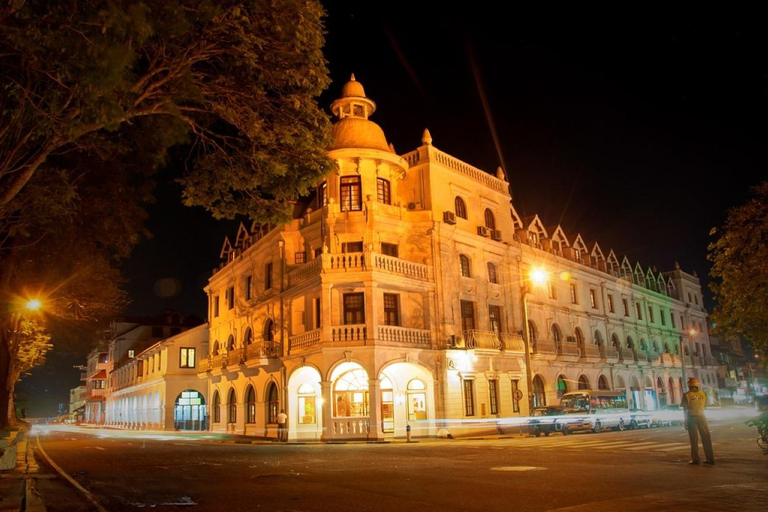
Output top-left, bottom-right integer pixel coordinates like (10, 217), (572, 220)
(24, 417), (768, 512)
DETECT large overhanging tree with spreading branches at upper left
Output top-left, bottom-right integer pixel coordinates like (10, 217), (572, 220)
(0, 0), (333, 427)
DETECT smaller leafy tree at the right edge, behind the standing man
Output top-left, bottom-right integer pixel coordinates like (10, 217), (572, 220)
(707, 181), (768, 362)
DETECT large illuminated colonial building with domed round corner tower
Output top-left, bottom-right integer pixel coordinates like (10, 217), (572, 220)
(201, 76), (716, 440)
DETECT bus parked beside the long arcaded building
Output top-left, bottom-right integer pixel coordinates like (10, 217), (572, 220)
(560, 389), (632, 433)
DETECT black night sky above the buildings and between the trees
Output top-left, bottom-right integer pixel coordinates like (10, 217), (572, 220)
(19, 1), (768, 414)
